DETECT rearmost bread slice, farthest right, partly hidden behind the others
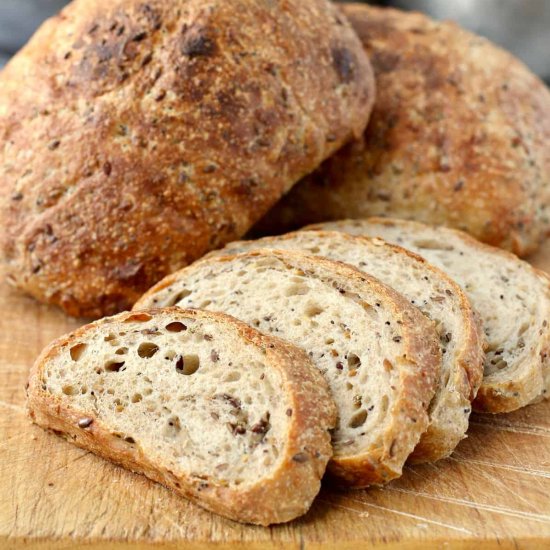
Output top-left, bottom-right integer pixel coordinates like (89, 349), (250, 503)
(315, 218), (550, 413)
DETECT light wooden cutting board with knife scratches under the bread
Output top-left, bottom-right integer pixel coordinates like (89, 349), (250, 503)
(0, 243), (550, 550)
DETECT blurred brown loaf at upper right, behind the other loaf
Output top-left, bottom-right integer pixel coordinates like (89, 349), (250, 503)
(263, 4), (550, 255)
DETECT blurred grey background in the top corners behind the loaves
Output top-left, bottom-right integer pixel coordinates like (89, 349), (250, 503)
(0, 0), (550, 81)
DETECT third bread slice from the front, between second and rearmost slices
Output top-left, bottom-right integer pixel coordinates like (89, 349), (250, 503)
(211, 231), (484, 462)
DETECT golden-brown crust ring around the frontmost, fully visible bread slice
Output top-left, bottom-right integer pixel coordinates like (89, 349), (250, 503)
(27, 308), (336, 525)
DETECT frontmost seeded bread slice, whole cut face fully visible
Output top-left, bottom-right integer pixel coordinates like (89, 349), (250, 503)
(28, 308), (336, 525)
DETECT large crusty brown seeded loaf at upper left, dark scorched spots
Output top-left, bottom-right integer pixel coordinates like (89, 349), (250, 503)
(0, 0), (374, 317)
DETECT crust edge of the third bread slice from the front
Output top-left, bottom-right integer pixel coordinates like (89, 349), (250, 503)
(211, 231), (485, 462)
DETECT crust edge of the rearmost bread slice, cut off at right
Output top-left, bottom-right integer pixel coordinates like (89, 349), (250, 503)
(327, 218), (550, 413)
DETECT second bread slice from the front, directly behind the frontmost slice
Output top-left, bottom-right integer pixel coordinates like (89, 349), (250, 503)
(136, 250), (441, 487)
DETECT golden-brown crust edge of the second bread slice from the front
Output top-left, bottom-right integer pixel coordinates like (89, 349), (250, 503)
(134, 249), (441, 487)
